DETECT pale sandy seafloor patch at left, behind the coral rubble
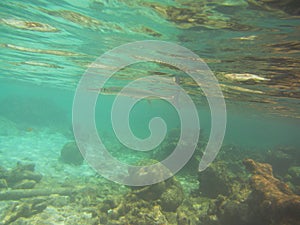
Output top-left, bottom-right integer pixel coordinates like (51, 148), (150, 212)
(0, 129), (95, 180)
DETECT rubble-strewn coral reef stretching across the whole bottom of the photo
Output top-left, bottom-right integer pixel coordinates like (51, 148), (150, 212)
(0, 146), (300, 225)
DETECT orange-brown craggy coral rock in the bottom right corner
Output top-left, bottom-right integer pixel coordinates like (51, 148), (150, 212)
(244, 159), (300, 225)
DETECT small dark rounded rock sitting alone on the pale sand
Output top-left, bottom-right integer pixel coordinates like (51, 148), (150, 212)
(60, 141), (84, 166)
